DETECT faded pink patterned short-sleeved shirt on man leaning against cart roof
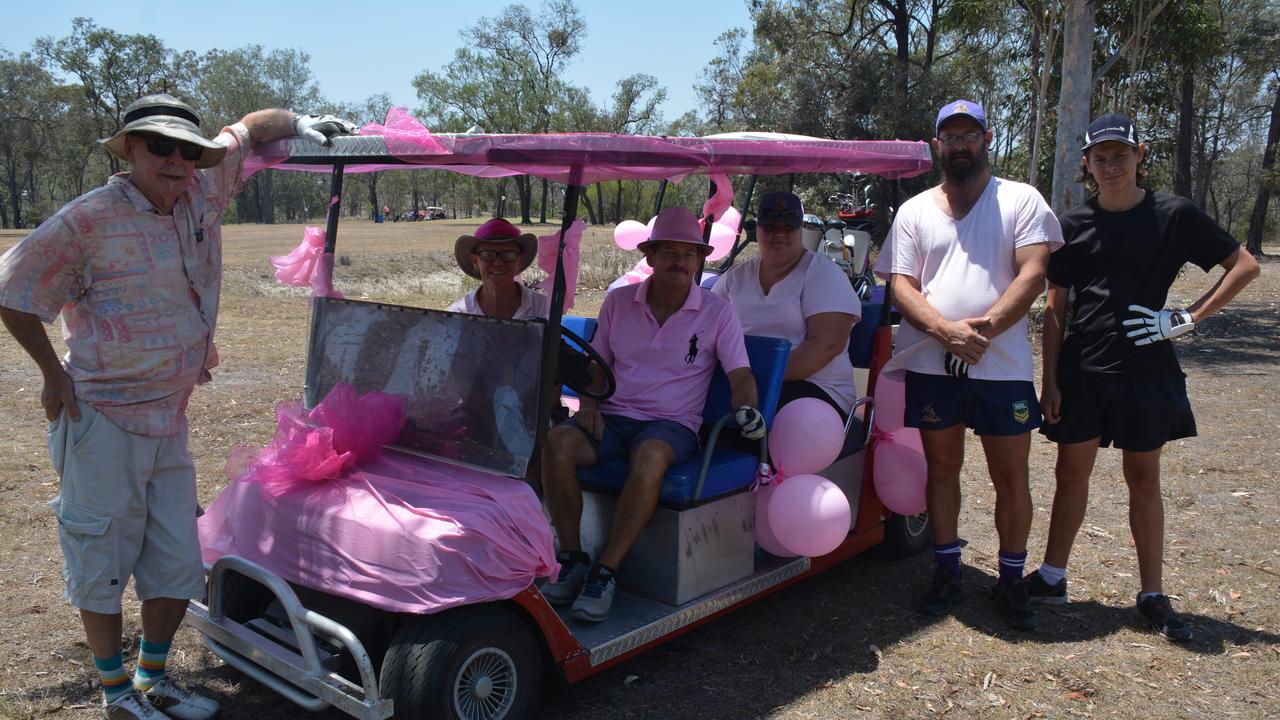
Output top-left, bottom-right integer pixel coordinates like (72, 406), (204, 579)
(0, 123), (250, 436)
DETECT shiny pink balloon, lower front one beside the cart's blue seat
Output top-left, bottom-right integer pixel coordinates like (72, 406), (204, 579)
(756, 475), (852, 557)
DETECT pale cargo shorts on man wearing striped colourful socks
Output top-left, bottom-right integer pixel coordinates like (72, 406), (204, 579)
(46, 402), (205, 614)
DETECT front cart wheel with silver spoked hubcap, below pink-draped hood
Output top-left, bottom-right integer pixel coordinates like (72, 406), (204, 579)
(379, 605), (543, 720)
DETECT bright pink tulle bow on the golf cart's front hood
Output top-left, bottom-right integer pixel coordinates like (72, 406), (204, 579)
(239, 383), (404, 498)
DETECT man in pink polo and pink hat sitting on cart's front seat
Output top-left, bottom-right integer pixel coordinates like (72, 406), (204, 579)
(541, 208), (764, 621)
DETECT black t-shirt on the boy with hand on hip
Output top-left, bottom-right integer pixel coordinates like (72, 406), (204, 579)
(1048, 191), (1240, 374)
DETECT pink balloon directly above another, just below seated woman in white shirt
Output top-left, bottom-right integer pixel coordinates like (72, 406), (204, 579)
(769, 397), (845, 475)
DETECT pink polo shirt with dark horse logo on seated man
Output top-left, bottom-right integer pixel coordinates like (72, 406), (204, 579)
(591, 279), (750, 433)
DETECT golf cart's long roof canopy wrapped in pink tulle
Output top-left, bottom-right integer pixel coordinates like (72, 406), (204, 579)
(248, 109), (932, 186)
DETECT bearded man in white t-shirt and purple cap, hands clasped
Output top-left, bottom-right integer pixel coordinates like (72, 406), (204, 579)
(876, 100), (1062, 630)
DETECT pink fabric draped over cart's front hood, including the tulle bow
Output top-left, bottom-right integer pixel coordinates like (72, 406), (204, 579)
(200, 386), (559, 614)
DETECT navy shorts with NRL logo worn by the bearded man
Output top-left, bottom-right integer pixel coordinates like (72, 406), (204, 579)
(904, 370), (1041, 436)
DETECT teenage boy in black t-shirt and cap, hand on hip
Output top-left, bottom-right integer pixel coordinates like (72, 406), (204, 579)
(1027, 114), (1258, 642)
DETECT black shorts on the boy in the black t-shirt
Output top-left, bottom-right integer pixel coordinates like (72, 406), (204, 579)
(1041, 370), (1196, 452)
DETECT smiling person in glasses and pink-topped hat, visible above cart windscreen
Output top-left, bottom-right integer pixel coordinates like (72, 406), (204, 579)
(448, 218), (548, 320)
